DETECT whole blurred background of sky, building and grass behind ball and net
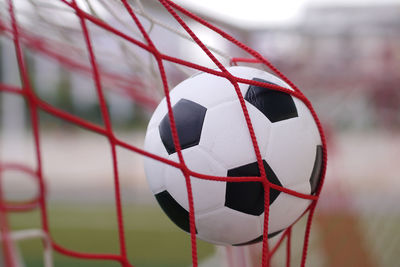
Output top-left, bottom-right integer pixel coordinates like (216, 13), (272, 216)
(0, 0), (400, 267)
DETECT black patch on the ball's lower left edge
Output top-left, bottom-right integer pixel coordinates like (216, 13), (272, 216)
(155, 190), (197, 234)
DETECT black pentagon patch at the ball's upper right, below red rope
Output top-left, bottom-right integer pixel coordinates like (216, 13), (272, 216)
(244, 78), (298, 122)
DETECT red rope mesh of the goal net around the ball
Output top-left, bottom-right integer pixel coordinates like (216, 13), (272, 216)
(0, 0), (327, 267)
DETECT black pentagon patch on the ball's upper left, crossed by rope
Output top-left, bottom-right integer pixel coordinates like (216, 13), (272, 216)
(158, 99), (207, 155)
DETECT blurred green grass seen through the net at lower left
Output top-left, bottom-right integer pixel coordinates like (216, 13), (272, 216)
(10, 204), (214, 267)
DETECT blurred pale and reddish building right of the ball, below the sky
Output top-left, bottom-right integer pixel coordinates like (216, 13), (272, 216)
(250, 4), (400, 128)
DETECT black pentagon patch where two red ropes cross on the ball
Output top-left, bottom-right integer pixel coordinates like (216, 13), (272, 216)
(225, 160), (282, 216)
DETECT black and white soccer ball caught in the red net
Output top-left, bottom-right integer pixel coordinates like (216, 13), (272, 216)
(144, 66), (322, 245)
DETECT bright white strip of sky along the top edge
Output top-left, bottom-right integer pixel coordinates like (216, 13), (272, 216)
(175, 0), (400, 27)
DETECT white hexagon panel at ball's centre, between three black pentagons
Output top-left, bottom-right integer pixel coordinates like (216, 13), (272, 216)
(199, 100), (271, 169)
